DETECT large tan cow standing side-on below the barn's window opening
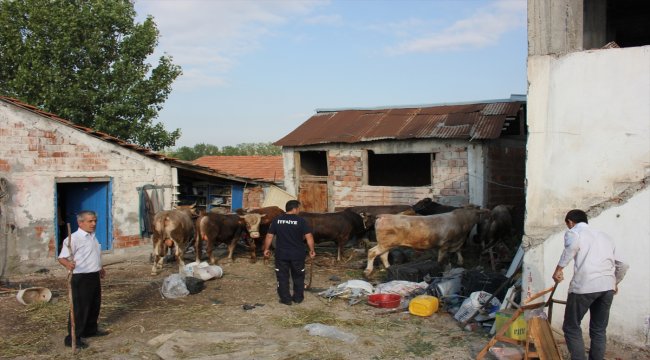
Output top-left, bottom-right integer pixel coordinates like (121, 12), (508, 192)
(364, 206), (490, 278)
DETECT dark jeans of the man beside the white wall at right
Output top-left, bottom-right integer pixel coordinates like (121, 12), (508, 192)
(562, 290), (614, 360)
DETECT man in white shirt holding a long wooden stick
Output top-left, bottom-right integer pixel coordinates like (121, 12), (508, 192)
(59, 210), (108, 349)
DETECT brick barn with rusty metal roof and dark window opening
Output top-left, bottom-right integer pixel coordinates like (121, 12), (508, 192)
(275, 95), (526, 222)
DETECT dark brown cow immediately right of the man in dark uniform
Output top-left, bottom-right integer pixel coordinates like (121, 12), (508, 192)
(298, 210), (366, 261)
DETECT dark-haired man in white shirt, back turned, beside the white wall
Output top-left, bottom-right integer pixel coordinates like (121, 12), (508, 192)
(553, 209), (628, 360)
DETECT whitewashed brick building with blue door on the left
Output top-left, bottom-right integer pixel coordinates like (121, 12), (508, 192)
(0, 97), (255, 277)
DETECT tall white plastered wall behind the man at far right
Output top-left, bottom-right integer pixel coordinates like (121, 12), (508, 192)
(523, 45), (650, 346)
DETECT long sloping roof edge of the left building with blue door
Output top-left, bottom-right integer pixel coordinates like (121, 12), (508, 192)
(0, 96), (255, 183)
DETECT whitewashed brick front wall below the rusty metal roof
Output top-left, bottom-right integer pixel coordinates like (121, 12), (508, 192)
(283, 140), (484, 211)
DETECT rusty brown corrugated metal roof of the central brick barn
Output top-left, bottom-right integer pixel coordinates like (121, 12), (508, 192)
(275, 100), (525, 146)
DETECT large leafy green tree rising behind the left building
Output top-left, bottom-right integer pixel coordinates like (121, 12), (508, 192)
(0, 0), (181, 150)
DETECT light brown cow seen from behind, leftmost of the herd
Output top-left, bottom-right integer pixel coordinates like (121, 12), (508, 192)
(151, 210), (194, 275)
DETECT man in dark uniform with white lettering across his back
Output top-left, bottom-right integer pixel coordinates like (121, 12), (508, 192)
(264, 200), (316, 305)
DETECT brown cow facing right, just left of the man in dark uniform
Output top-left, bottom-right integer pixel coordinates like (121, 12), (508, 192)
(194, 212), (263, 265)
